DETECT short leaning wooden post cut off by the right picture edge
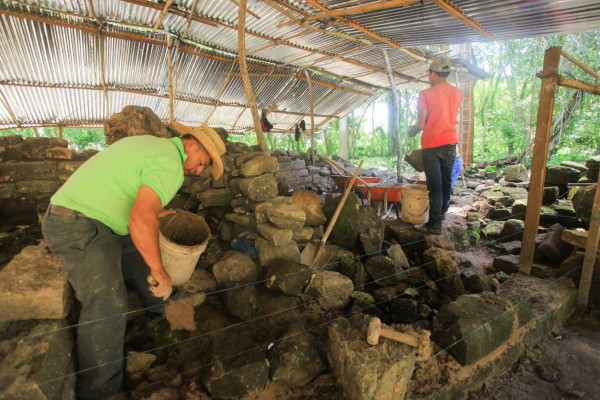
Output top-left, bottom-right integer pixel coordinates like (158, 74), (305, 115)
(577, 176), (600, 309)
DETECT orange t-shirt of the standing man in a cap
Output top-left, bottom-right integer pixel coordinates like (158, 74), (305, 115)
(417, 83), (462, 149)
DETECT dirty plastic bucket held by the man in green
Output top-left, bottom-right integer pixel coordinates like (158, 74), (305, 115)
(158, 210), (210, 286)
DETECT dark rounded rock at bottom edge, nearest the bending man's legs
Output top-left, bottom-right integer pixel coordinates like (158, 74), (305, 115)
(200, 329), (269, 399)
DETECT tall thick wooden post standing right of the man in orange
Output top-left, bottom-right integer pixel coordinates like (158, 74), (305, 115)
(519, 47), (560, 275)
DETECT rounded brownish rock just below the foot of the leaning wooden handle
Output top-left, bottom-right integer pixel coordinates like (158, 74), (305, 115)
(306, 271), (354, 310)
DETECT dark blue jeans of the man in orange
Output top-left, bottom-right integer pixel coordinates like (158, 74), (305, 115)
(421, 144), (456, 226)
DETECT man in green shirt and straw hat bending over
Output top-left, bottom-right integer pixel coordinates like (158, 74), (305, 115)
(42, 123), (225, 399)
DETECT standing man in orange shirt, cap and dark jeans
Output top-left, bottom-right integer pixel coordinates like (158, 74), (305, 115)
(408, 57), (462, 235)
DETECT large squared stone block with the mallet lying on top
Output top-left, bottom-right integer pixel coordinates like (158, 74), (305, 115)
(327, 319), (415, 400)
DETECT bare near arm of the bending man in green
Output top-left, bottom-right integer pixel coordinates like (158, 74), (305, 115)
(129, 185), (173, 300)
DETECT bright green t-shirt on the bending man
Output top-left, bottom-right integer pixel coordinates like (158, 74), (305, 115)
(50, 136), (187, 235)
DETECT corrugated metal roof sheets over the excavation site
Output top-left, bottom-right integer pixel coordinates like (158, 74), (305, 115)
(0, 0), (600, 131)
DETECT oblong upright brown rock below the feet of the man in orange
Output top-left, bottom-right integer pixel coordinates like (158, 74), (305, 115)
(423, 247), (465, 297)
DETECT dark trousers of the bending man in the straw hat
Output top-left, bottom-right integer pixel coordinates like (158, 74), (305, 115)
(42, 206), (162, 399)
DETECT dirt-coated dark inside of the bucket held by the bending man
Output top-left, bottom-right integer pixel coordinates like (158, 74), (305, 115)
(160, 211), (210, 246)
